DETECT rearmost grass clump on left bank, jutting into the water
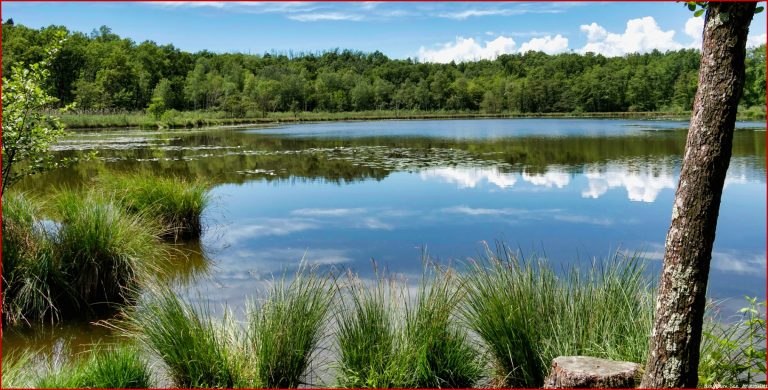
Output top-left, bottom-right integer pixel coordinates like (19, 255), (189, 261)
(102, 174), (210, 239)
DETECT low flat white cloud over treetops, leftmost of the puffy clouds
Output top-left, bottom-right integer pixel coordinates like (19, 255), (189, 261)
(419, 36), (516, 63)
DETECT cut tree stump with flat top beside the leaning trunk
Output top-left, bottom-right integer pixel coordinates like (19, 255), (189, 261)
(544, 356), (642, 389)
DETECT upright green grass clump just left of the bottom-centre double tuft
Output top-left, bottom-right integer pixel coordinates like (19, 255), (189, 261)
(248, 263), (335, 388)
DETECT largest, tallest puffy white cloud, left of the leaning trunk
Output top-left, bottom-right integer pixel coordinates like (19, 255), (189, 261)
(578, 16), (683, 57)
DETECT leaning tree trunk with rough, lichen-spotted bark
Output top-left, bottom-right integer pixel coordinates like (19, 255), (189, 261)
(640, 2), (755, 388)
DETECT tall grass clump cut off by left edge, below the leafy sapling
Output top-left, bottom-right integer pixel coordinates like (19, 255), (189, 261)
(2, 193), (69, 324)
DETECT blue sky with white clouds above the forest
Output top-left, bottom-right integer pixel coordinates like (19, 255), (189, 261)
(2, 1), (766, 62)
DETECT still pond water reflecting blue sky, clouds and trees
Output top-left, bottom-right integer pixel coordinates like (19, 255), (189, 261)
(3, 119), (766, 360)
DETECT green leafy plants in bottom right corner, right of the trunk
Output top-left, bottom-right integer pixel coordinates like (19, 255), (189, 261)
(699, 297), (766, 387)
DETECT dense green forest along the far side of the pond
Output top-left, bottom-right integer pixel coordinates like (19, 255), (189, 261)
(2, 19), (766, 118)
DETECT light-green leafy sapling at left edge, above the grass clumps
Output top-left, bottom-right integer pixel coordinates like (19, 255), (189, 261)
(1, 31), (70, 193)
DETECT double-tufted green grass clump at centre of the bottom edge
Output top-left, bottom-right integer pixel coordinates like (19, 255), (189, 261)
(336, 262), (483, 388)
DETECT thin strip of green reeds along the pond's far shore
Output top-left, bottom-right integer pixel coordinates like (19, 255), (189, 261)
(60, 110), (765, 129)
